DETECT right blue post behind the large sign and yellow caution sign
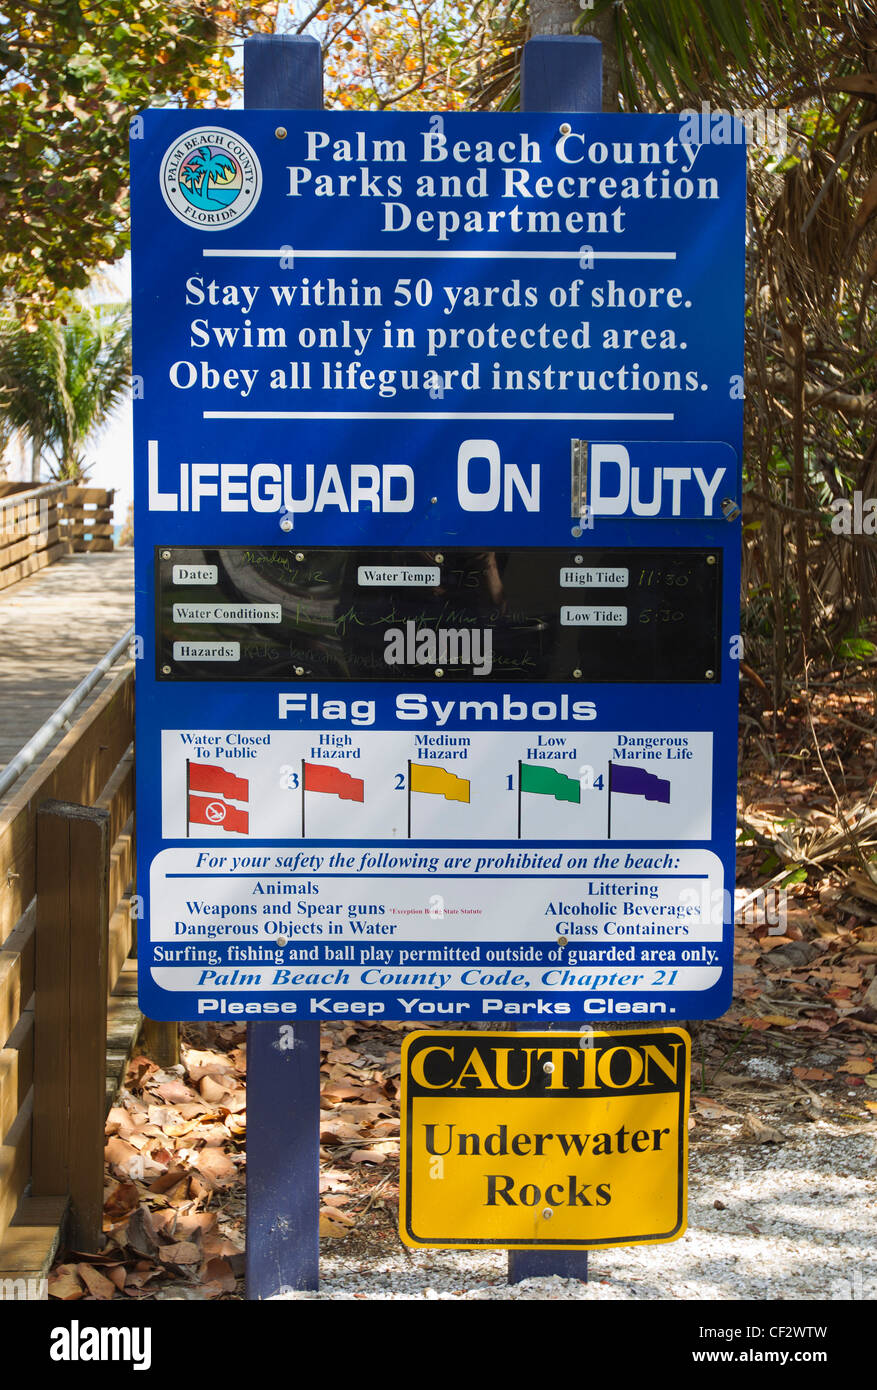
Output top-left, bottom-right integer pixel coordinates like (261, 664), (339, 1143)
(507, 35), (603, 1284)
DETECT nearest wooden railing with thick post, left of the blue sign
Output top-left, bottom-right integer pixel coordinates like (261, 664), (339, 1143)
(0, 666), (136, 1279)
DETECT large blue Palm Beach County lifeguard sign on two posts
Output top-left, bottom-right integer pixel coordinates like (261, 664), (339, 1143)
(132, 110), (745, 1023)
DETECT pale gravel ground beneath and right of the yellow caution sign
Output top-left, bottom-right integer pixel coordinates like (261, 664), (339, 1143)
(275, 1120), (877, 1302)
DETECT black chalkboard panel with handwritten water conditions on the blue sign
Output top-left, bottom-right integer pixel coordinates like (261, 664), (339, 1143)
(156, 546), (721, 684)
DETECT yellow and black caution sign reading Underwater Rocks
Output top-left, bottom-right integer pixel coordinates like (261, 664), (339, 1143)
(399, 1029), (691, 1250)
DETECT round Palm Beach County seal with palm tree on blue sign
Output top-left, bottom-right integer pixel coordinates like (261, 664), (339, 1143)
(160, 125), (261, 232)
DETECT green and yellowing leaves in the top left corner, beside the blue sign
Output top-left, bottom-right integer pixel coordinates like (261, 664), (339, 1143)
(0, 0), (277, 313)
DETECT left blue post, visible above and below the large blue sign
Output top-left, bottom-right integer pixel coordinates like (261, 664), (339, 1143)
(243, 35), (322, 1301)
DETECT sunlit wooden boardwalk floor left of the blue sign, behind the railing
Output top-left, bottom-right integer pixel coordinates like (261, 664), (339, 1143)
(0, 546), (133, 803)
